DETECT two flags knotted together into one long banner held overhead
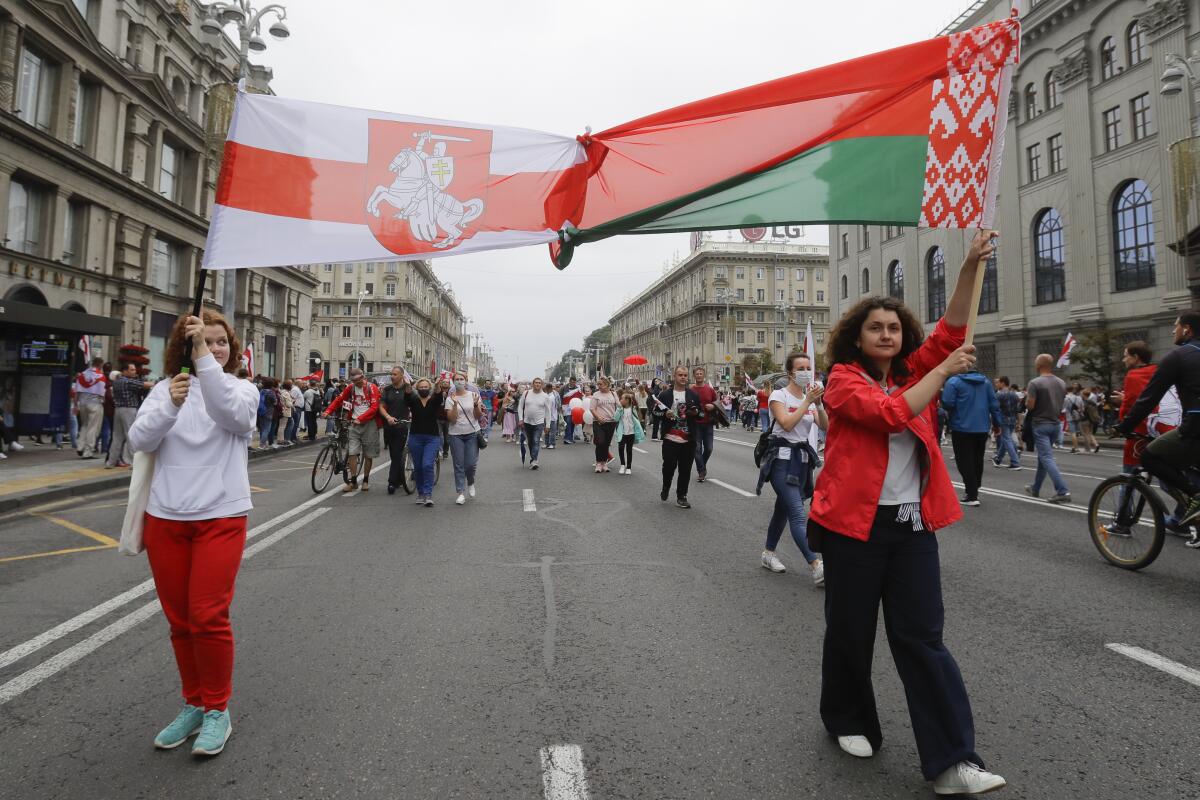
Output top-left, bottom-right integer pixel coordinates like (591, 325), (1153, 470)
(204, 17), (1020, 269)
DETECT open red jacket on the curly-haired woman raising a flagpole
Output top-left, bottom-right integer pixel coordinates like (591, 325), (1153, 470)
(811, 320), (966, 541)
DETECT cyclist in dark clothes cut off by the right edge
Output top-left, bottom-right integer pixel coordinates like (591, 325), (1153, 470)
(1116, 311), (1200, 524)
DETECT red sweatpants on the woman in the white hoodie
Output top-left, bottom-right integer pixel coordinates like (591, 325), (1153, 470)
(143, 513), (246, 711)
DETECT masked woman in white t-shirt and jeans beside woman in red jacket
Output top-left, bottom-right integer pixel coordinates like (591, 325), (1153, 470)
(758, 353), (829, 587)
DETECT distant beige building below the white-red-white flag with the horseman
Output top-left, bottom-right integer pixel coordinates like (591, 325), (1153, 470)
(305, 261), (469, 377)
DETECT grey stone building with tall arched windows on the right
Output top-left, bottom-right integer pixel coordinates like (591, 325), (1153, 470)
(829, 0), (1200, 383)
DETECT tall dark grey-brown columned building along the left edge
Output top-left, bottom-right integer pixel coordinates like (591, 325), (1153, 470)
(0, 0), (316, 431)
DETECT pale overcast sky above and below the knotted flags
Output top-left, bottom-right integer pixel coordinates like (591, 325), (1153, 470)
(260, 0), (970, 377)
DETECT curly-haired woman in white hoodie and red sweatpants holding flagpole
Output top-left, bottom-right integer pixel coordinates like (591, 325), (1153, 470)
(128, 312), (258, 756)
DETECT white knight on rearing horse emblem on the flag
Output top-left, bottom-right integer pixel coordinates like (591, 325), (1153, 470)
(367, 131), (484, 249)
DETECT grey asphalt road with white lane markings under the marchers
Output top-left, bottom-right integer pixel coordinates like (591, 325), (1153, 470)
(0, 428), (1200, 800)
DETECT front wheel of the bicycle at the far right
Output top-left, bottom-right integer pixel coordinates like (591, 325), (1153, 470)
(1087, 475), (1165, 570)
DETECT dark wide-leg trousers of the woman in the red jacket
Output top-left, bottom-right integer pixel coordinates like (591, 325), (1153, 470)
(809, 506), (983, 781)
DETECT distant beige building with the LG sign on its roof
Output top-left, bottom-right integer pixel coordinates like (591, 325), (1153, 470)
(608, 236), (830, 384)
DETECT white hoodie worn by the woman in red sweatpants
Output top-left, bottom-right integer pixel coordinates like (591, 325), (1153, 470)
(128, 353), (258, 521)
